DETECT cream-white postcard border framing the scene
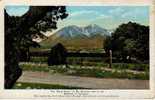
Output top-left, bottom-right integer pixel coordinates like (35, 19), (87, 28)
(0, 0), (155, 99)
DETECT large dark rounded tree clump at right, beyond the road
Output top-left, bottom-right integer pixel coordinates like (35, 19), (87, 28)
(105, 22), (149, 62)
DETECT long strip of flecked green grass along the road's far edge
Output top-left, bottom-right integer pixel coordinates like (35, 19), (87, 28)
(20, 64), (149, 80)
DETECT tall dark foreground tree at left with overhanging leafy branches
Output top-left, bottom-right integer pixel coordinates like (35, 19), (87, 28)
(5, 6), (68, 88)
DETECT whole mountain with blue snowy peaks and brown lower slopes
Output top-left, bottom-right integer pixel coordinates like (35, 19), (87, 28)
(40, 24), (110, 49)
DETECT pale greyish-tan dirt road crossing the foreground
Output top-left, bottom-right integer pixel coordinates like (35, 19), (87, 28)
(18, 71), (149, 89)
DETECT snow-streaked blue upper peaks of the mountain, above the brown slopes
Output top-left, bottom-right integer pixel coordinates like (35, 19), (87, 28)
(55, 24), (110, 38)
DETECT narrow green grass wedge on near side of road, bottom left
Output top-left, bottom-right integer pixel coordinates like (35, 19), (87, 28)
(13, 82), (83, 89)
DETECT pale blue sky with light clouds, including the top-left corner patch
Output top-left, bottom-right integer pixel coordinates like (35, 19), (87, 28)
(6, 6), (149, 29)
